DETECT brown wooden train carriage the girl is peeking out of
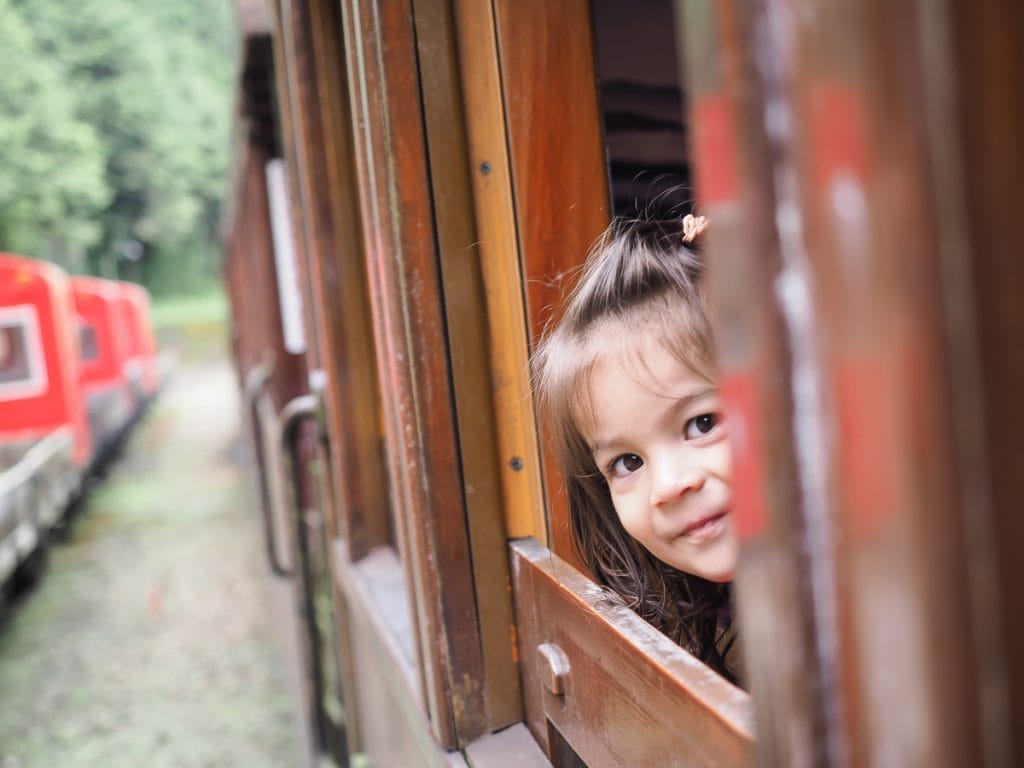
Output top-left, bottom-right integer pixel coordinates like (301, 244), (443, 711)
(225, 0), (1024, 768)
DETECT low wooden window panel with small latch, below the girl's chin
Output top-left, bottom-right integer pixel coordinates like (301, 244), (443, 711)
(512, 540), (753, 768)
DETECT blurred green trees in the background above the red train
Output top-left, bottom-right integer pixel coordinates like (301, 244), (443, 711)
(0, 0), (236, 294)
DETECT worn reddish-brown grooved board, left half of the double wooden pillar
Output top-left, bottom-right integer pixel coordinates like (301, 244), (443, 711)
(346, 3), (485, 748)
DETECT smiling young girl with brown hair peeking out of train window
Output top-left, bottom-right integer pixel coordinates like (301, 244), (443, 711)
(534, 216), (737, 682)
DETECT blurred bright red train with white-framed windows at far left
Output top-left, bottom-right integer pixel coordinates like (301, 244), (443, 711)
(0, 254), (159, 601)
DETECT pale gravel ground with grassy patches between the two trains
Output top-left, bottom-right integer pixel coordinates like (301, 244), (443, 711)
(0, 362), (304, 768)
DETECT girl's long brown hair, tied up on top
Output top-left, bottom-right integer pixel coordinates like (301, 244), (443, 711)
(532, 220), (735, 682)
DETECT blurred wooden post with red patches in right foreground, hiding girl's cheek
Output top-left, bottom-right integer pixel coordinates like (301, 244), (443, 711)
(680, 0), (1024, 765)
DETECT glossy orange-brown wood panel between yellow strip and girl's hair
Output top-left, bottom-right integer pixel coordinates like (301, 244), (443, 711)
(495, 0), (609, 562)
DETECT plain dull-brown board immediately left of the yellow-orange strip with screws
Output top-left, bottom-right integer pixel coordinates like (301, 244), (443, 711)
(414, 0), (522, 740)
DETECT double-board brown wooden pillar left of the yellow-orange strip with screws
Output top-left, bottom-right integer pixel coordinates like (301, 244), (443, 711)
(339, 0), (521, 750)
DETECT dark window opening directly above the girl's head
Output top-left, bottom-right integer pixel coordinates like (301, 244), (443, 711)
(592, 0), (693, 217)
